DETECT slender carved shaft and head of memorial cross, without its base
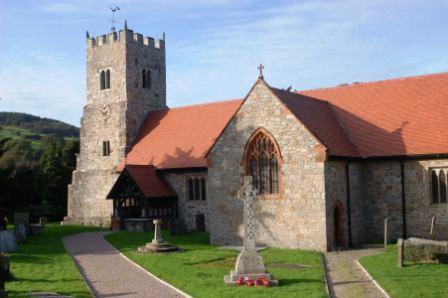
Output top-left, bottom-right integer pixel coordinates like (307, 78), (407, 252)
(241, 176), (257, 251)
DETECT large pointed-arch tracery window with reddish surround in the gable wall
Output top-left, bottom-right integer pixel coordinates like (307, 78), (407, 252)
(245, 130), (280, 194)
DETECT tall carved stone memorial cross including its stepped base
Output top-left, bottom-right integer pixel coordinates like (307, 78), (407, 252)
(224, 176), (278, 285)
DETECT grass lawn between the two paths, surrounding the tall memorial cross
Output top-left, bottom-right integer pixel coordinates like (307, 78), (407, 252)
(106, 232), (327, 297)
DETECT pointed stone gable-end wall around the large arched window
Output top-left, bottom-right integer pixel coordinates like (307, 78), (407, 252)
(208, 80), (327, 251)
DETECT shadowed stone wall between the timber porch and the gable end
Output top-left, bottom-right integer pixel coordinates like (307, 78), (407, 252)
(164, 171), (210, 231)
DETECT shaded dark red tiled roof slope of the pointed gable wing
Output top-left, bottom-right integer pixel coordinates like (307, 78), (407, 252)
(271, 87), (359, 157)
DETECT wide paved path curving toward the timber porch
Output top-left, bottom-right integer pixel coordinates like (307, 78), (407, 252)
(63, 232), (183, 298)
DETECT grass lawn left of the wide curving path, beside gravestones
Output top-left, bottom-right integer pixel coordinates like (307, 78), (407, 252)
(6, 223), (103, 297)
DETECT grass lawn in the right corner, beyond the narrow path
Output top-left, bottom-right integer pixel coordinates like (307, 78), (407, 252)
(360, 245), (448, 298)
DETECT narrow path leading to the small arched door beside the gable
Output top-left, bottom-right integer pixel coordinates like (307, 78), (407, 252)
(325, 248), (385, 298)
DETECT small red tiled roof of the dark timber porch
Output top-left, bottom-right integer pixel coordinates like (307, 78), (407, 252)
(126, 165), (176, 198)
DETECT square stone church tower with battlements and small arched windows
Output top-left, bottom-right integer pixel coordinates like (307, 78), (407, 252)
(64, 23), (166, 226)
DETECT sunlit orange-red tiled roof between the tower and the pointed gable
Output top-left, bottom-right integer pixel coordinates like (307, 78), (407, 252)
(118, 100), (242, 170)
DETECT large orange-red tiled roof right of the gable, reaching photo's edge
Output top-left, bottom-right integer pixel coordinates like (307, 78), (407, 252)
(300, 73), (448, 157)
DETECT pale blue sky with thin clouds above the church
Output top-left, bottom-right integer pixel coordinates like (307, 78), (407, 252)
(0, 0), (448, 125)
